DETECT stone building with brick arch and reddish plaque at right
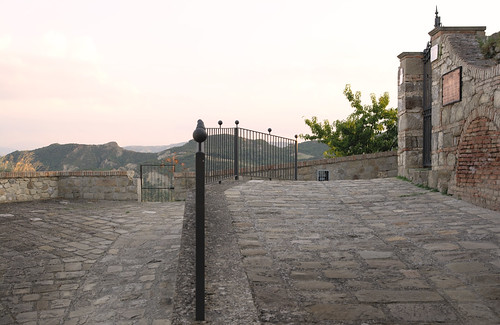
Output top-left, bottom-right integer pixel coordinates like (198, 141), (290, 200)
(398, 12), (500, 210)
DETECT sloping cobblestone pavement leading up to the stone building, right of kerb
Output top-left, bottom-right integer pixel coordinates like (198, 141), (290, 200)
(222, 179), (500, 324)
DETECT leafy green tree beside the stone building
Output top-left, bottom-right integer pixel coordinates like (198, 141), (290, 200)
(301, 84), (398, 157)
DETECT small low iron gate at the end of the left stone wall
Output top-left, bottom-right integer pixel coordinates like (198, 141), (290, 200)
(141, 165), (175, 202)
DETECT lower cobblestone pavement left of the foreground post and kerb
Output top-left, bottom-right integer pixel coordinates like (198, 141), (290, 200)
(0, 200), (184, 325)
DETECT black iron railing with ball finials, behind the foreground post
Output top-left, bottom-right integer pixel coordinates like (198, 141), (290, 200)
(205, 121), (298, 183)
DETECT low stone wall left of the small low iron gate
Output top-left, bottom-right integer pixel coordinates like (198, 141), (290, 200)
(0, 171), (138, 203)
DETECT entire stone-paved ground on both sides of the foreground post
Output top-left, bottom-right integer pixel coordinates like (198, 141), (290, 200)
(0, 178), (500, 325)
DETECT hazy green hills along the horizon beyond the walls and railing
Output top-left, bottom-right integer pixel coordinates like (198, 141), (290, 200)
(1, 140), (328, 173)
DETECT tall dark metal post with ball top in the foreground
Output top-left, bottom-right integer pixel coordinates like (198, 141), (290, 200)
(193, 120), (207, 321)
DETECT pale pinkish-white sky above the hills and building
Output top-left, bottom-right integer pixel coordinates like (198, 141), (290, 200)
(0, 0), (500, 154)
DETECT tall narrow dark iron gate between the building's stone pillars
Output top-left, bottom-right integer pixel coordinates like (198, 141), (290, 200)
(422, 42), (432, 167)
